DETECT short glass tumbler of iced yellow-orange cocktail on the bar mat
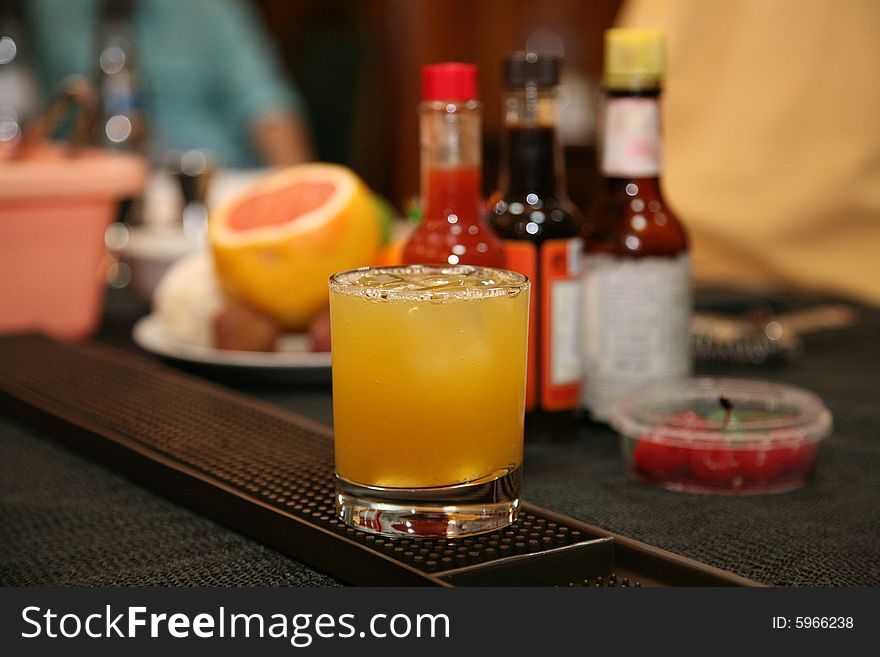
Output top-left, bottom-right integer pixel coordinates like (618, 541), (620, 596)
(330, 265), (529, 535)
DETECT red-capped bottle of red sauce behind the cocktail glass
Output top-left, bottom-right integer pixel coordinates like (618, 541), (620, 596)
(403, 62), (504, 267)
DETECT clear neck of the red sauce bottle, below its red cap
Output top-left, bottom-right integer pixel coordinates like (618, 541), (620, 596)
(419, 100), (482, 223)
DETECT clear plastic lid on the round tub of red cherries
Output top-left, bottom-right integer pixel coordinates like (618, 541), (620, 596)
(609, 378), (832, 446)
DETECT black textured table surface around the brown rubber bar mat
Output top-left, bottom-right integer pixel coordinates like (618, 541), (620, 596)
(0, 290), (880, 586)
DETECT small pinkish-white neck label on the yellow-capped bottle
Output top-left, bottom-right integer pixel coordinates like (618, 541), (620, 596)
(602, 98), (661, 177)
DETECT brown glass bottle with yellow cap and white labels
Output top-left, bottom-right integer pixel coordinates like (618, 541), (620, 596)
(582, 29), (691, 421)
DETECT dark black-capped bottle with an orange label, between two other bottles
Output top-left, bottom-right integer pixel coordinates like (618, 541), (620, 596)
(490, 52), (583, 429)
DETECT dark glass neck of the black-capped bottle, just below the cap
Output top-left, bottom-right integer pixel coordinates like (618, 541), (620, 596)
(499, 85), (565, 198)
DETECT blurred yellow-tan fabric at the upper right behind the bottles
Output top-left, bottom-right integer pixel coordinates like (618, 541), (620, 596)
(618, 0), (880, 304)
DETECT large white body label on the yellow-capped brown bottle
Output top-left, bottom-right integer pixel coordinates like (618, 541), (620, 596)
(582, 253), (691, 420)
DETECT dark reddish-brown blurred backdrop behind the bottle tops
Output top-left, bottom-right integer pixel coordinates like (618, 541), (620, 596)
(241, 0), (620, 207)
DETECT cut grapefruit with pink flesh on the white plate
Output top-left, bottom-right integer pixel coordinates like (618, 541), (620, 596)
(208, 163), (382, 331)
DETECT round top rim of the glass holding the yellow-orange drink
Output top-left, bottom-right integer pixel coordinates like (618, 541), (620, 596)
(329, 265), (531, 301)
